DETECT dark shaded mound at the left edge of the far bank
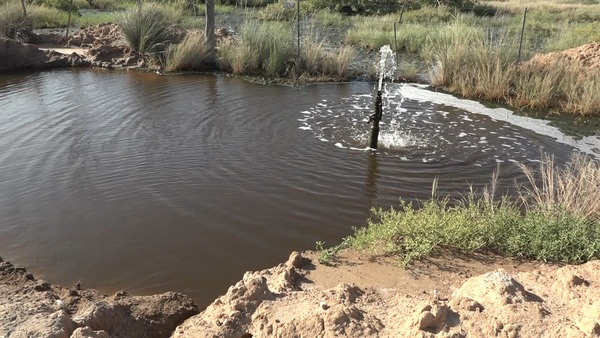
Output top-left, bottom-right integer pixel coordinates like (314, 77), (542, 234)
(0, 38), (48, 71)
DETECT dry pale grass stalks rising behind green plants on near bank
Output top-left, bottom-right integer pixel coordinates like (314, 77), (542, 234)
(519, 153), (600, 221)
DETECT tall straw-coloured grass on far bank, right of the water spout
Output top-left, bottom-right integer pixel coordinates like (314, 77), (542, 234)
(421, 17), (600, 116)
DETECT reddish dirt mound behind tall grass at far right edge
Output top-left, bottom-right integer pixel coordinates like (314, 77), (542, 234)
(525, 42), (600, 69)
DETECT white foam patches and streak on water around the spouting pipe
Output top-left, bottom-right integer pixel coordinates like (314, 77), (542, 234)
(299, 84), (600, 165)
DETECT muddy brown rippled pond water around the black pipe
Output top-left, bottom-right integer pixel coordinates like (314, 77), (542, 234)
(0, 70), (592, 307)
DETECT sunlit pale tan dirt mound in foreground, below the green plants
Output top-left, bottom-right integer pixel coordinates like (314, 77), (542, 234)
(173, 253), (600, 338)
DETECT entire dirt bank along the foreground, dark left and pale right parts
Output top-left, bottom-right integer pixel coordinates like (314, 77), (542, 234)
(0, 251), (600, 338)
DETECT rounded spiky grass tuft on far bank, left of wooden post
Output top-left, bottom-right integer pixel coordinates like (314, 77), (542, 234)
(119, 3), (179, 54)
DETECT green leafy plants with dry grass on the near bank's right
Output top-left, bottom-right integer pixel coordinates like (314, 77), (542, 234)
(321, 154), (600, 265)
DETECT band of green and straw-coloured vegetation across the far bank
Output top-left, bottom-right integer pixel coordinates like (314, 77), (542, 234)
(0, 0), (600, 111)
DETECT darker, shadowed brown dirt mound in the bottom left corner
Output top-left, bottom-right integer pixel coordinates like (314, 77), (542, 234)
(0, 258), (198, 338)
